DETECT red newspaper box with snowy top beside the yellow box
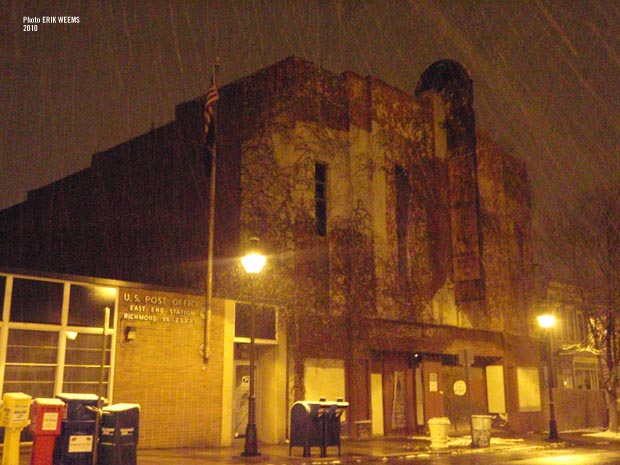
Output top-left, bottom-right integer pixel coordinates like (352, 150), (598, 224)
(30, 399), (65, 465)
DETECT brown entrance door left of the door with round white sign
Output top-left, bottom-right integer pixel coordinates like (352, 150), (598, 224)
(383, 354), (415, 436)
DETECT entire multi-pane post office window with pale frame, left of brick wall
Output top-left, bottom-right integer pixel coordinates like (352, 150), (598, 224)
(0, 276), (118, 397)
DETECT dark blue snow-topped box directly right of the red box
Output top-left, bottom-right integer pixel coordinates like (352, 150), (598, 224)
(54, 393), (99, 465)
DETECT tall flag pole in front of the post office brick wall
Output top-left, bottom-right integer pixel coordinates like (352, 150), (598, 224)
(204, 57), (220, 361)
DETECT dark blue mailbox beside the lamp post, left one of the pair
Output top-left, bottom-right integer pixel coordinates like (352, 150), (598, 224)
(288, 401), (326, 457)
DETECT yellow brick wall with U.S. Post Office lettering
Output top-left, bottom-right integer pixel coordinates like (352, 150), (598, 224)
(113, 288), (224, 447)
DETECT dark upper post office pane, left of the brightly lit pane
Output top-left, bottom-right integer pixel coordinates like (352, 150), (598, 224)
(11, 278), (63, 324)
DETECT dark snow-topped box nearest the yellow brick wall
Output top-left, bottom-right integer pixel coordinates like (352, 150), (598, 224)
(97, 404), (140, 465)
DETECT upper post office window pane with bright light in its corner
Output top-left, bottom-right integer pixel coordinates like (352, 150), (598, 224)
(69, 284), (117, 328)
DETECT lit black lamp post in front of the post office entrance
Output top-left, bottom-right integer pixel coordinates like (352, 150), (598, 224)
(241, 237), (267, 457)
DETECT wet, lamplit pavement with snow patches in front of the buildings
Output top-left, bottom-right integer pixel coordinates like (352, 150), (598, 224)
(11, 432), (620, 465)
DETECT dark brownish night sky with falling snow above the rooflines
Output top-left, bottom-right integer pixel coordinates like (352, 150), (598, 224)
(0, 0), (620, 260)
